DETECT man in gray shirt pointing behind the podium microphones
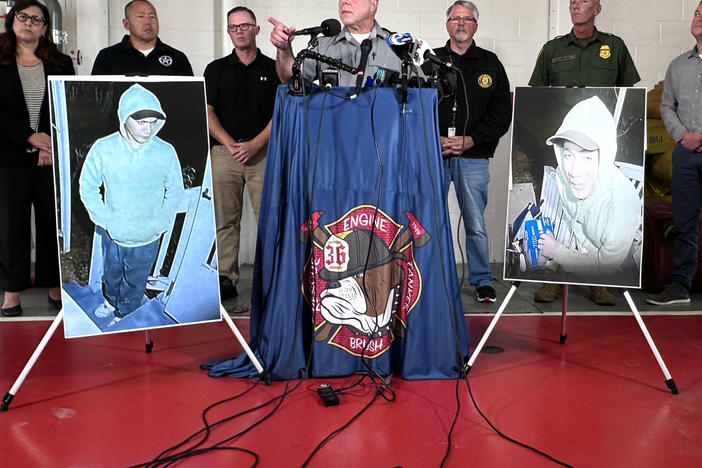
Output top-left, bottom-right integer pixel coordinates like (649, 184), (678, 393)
(268, 0), (401, 86)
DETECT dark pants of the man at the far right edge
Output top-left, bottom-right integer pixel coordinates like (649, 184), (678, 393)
(670, 144), (702, 291)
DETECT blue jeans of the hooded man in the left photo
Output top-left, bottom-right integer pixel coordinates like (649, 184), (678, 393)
(95, 226), (158, 317)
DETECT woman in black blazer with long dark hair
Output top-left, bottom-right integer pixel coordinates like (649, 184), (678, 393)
(0, 0), (75, 317)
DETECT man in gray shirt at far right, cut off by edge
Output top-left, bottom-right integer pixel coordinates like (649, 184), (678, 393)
(646, 2), (702, 305)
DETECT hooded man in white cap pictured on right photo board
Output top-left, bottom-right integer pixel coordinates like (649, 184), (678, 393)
(538, 96), (641, 277)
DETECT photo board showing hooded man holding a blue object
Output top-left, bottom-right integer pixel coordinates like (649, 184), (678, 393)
(504, 87), (646, 288)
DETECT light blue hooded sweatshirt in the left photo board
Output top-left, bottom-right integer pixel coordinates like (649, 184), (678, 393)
(79, 84), (184, 247)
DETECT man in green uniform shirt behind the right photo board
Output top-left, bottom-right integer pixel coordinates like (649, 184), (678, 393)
(529, 0), (641, 305)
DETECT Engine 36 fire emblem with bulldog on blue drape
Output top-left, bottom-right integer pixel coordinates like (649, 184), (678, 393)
(300, 205), (431, 358)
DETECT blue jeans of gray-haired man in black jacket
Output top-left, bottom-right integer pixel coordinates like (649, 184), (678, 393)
(443, 158), (492, 288)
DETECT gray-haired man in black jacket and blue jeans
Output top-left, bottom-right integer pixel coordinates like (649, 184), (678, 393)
(425, 1), (512, 302)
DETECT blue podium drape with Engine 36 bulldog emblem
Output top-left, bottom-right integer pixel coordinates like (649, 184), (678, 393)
(203, 86), (468, 379)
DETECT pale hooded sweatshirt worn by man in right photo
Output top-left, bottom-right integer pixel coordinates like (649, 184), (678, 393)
(546, 96), (641, 275)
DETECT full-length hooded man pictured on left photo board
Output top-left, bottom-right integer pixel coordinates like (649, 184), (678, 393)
(79, 84), (184, 325)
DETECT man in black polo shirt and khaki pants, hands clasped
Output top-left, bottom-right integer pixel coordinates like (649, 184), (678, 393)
(205, 6), (280, 299)
